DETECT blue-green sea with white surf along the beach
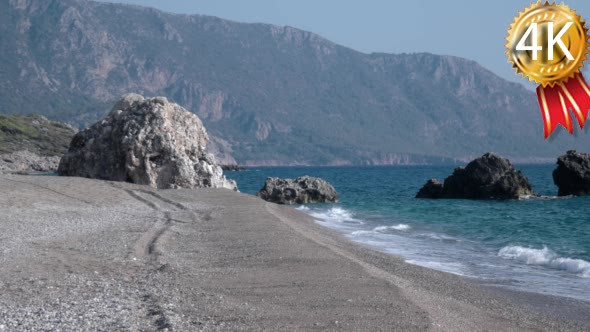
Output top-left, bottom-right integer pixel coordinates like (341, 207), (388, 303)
(225, 165), (590, 301)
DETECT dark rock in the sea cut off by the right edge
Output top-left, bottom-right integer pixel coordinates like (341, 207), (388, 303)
(553, 151), (590, 196)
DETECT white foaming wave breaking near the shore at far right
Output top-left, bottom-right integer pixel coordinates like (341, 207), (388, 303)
(498, 246), (590, 278)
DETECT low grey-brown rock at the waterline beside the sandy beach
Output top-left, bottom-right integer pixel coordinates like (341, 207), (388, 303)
(258, 176), (338, 204)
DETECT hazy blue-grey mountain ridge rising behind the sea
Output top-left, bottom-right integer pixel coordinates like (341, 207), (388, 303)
(0, 0), (588, 165)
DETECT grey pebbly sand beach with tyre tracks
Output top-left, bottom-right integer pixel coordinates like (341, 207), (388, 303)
(0, 175), (590, 331)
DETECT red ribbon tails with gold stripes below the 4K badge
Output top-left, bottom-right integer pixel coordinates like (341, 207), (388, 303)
(537, 74), (590, 138)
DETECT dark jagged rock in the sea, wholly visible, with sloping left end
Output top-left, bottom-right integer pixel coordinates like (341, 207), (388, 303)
(416, 153), (535, 199)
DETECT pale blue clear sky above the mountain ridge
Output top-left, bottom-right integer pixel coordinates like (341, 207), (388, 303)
(97, 0), (590, 88)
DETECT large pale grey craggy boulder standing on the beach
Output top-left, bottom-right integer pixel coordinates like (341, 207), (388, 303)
(58, 94), (237, 190)
